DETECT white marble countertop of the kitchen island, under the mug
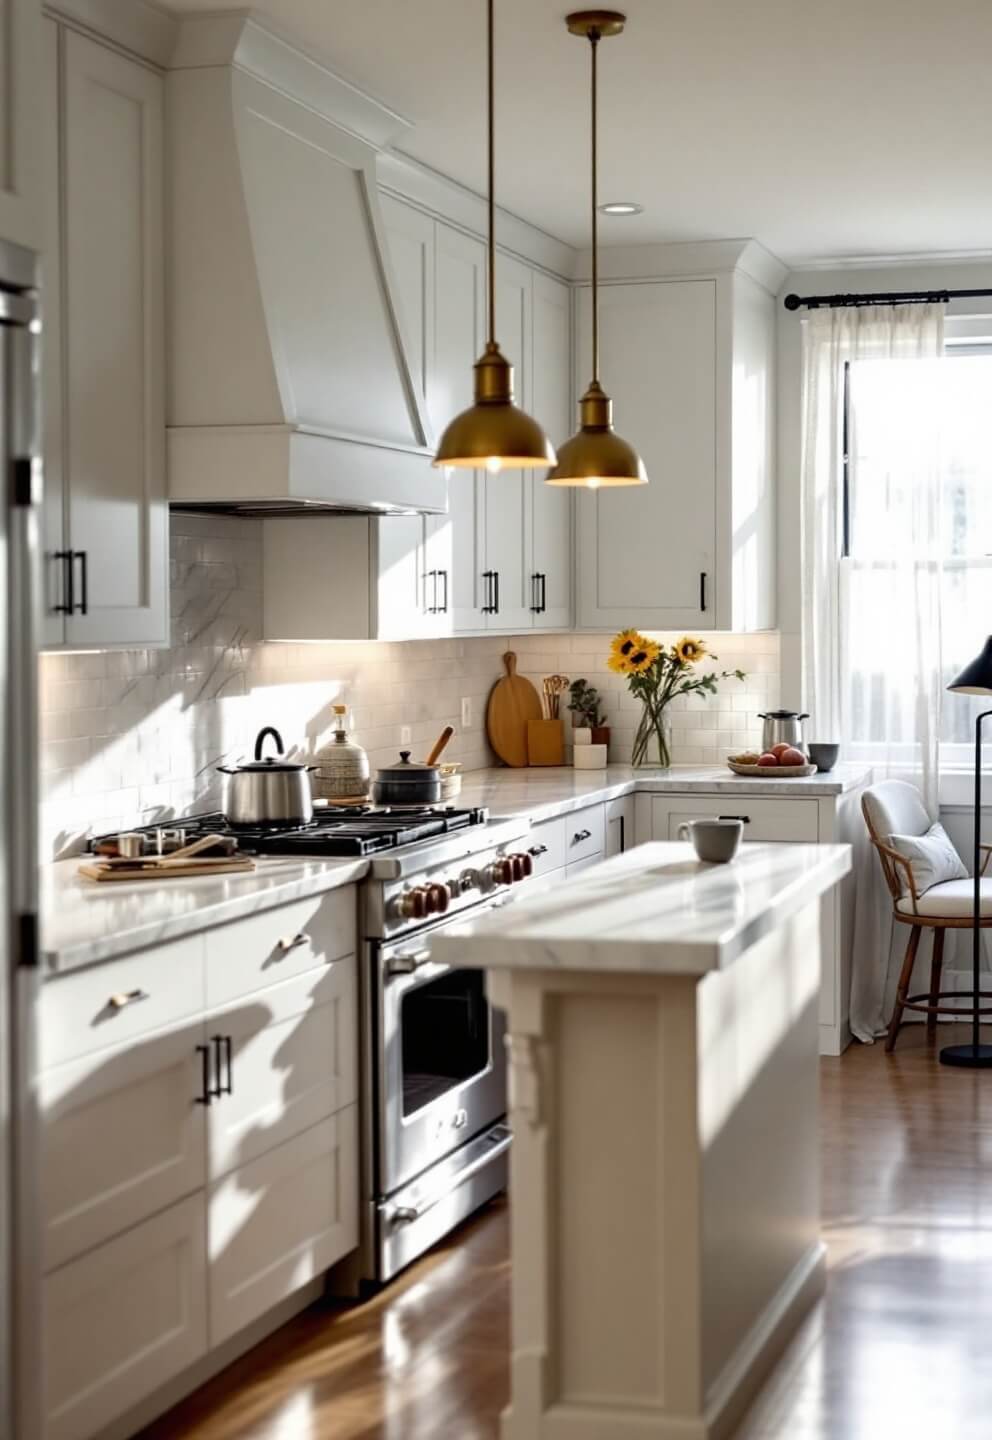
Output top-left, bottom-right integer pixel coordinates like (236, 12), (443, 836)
(430, 842), (851, 975)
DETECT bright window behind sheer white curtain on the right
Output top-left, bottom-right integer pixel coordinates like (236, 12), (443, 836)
(841, 340), (992, 765)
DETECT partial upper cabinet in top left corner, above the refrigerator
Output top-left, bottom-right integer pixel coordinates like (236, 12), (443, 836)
(0, 0), (42, 251)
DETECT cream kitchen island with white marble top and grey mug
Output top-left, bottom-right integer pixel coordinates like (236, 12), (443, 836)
(433, 844), (851, 1440)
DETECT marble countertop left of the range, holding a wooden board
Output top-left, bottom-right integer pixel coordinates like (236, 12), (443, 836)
(42, 858), (369, 975)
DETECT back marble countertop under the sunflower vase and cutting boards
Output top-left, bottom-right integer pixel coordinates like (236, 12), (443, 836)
(456, 765), (871, 821)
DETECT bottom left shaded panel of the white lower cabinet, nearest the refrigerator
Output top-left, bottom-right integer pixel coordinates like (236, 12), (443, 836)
(45, 1194), (207, 1440)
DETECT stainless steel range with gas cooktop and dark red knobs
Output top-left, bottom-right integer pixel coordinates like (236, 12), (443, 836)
(94, 806), (531, 1293)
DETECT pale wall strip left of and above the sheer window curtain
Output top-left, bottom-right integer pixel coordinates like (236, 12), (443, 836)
(777, 261), (992, 707)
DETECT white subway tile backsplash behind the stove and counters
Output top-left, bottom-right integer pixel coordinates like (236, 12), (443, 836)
(40, 516), (790, 857)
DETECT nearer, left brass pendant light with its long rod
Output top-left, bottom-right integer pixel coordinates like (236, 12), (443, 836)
(433, 0), (554, 471)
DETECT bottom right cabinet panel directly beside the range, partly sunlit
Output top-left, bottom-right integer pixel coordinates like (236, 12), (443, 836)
(207, 1106), (359, 1345)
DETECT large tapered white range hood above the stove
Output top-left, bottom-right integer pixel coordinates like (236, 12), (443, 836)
(168, 14), (445, 514)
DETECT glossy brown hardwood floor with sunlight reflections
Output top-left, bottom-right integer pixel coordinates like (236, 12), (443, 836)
(141, 1025), (992, 1440)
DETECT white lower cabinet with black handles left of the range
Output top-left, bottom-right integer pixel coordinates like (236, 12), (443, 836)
(39, 888), (359, 1440)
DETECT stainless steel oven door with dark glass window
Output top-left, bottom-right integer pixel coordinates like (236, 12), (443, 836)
(376, 916), (507, 1195)
